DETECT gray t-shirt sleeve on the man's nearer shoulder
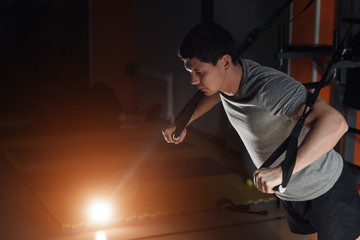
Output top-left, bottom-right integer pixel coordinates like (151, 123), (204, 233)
(258, 74), (308, 117)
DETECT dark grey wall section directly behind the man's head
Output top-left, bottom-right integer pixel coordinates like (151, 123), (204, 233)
(133, 0), (290, 142)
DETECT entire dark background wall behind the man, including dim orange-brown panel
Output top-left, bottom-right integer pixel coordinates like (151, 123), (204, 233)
(0, 0), (290, 142)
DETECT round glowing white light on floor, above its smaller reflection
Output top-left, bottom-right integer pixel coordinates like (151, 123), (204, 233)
(89, 201), (113, 224)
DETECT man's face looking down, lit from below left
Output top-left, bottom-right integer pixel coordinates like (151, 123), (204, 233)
(184, 58), (225, 96)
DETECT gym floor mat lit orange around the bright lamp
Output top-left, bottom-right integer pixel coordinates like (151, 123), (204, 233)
(0, 119), (275, 228)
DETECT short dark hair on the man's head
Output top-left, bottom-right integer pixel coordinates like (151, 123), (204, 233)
(178, 22), (237, 66)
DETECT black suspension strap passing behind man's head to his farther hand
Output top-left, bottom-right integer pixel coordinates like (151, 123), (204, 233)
(172, 0), (315, 140)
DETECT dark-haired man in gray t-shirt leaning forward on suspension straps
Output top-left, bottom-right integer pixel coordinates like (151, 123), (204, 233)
(162, 23), (360, 240)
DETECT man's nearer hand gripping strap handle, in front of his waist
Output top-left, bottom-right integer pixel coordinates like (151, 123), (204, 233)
(253, 165), (282, 194)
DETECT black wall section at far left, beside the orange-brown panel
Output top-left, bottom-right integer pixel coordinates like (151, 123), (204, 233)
(0, 0), (89, 124)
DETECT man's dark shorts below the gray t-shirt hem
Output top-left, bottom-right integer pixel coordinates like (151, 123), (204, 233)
(280, 163), (360, 240)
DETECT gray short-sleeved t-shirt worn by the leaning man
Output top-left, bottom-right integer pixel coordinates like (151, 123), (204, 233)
(220, 59), (343, 201)
